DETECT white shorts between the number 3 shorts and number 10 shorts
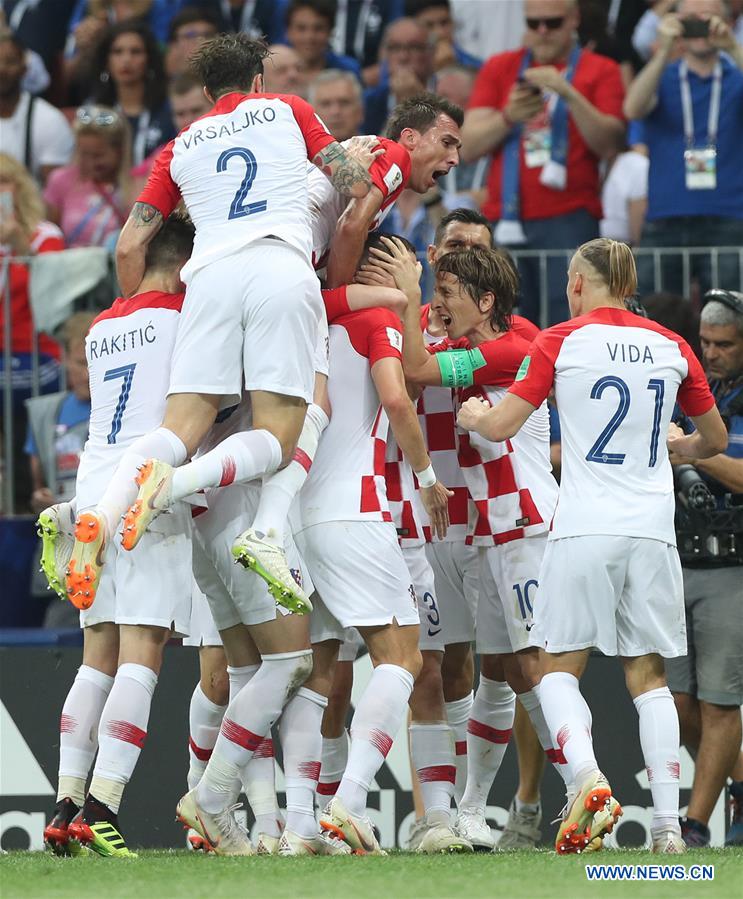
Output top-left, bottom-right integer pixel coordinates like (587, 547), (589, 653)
(428, 540), (480, 646)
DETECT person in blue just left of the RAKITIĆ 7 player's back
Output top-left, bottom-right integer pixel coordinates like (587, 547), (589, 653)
(24, 312), (95, 512)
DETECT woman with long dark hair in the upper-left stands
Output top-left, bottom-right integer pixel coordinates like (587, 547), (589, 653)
(86, 22), (175, 165)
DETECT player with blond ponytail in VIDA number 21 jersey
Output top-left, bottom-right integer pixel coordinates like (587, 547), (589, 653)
(458, 239), (727, 852)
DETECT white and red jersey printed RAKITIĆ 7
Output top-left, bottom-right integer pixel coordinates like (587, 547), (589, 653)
(77, 290), (183, 509)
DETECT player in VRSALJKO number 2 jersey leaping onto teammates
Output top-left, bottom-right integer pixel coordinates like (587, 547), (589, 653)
(68, 34), (371, 610)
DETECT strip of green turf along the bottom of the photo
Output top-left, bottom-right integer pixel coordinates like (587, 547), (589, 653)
(0, 849), (743, 899)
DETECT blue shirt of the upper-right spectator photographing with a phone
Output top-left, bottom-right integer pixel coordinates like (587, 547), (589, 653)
(643, 54), (743, 221)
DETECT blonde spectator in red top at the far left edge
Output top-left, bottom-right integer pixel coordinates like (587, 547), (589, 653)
(0, 153), (64, 512)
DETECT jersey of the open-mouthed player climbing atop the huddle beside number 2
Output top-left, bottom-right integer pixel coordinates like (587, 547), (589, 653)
(307, 137), (410, 269)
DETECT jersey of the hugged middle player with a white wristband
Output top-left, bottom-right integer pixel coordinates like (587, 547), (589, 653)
(300, 287), (402, 527)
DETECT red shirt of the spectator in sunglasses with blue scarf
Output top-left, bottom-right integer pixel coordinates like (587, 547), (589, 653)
(474, 48), (624, 221)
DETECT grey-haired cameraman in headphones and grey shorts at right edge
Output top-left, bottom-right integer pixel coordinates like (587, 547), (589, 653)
(666, 290), (743, 846)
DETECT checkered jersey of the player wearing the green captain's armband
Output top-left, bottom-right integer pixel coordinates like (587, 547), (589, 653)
(430, 331), (557, 546)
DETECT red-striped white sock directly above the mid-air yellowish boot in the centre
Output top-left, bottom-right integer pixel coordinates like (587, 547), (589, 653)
(253, 403), (330, 546)
